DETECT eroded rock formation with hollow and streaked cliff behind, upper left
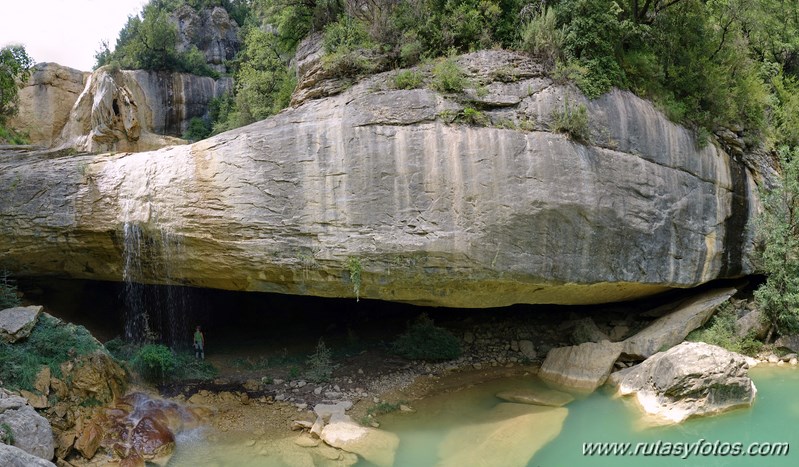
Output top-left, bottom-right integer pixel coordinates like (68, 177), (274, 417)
(55, 68), (233, 152)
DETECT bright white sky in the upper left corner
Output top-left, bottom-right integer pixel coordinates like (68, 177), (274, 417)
(0, 0), (147, 71)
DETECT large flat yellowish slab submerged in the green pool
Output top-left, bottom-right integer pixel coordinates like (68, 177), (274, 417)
(437, 403), (569, 467)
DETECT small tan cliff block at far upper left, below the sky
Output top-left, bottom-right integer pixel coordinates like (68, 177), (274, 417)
(9, 63), (89, 147)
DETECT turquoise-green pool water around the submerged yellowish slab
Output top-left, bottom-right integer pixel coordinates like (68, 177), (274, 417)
(381, 367), (799, 467)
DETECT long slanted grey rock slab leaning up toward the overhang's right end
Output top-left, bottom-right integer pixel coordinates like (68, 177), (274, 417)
(622, 287), (737, 359)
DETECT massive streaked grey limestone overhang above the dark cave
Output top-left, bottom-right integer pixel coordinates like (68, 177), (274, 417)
(0, 51), (757, 307)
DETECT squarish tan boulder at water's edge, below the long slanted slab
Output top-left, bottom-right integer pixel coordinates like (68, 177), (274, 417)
(538, 341), (622, 392)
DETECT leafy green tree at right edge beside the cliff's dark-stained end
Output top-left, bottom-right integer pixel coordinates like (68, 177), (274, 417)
(755, 147), (799, 342)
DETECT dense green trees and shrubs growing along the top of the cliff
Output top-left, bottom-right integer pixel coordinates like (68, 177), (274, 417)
(98, 0), (799, 147)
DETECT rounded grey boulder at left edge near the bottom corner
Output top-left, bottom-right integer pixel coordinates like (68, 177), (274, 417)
(0, 388), (55, 465)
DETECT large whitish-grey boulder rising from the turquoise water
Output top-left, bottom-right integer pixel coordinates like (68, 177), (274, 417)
(616, 342), (757, 423)
